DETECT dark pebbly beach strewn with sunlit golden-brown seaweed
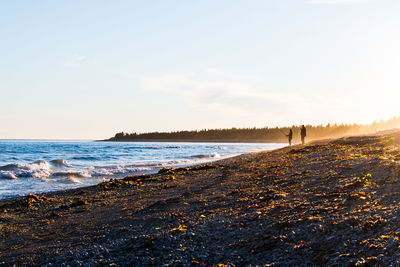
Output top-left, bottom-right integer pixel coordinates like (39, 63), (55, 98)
(0, 131), (400, 266)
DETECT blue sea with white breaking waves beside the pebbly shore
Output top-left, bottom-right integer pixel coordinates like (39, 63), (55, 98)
(0, 140), (287, 199)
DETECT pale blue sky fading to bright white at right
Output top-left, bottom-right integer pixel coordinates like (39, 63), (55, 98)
(0, 0), (400, 139)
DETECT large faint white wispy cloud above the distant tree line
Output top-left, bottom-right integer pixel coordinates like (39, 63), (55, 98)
(136, 69), (305, 120)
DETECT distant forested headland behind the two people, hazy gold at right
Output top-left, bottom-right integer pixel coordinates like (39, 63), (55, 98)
(106, 117), (400, 143)
